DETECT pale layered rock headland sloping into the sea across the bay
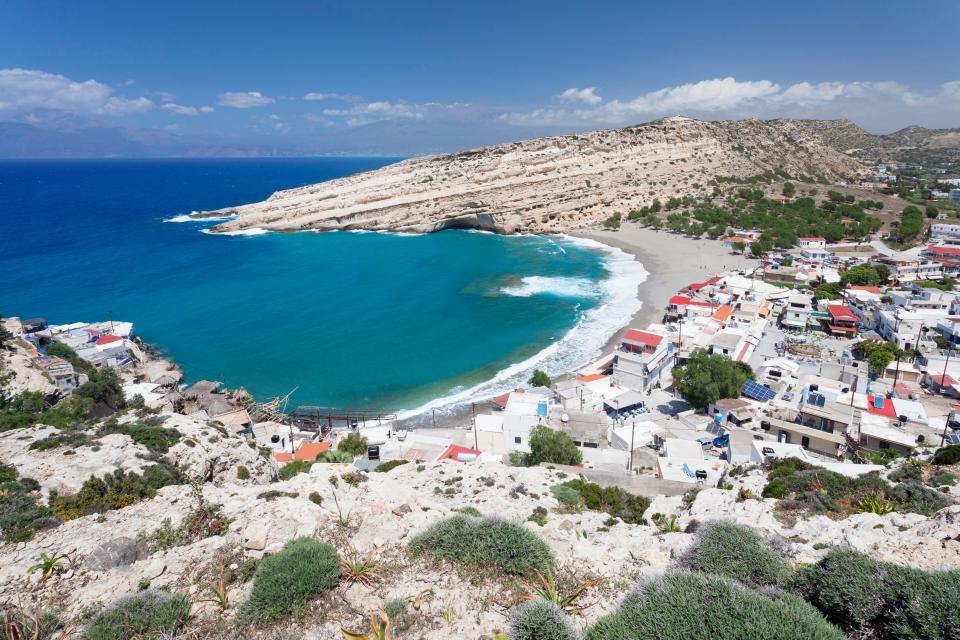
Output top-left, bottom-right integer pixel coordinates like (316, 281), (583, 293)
(196, 116), (865, 233)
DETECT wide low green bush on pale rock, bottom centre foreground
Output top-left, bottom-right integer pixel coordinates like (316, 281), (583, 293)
(410, 515), (554, 576)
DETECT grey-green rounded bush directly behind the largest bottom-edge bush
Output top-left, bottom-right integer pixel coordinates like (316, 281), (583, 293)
(680, 522), (791, 587)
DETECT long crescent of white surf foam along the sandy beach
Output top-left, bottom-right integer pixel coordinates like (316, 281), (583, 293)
(398, 236), (650, 419)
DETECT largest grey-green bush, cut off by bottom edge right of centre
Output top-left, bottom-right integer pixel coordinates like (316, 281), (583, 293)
(587, 571), (846, 640)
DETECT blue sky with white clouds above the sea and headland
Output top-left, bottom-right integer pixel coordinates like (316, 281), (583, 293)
(0, 0), (960, 153)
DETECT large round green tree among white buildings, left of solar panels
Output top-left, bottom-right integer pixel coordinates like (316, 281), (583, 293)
(673, 350), (754, 409)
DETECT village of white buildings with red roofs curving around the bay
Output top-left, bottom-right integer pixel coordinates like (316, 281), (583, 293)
(5, 210), (960, 493)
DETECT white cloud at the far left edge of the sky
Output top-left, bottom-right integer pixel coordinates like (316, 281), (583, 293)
(0, 69), (154, 115)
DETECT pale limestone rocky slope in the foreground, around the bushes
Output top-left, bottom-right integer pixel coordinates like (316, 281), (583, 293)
(0, 414), (960, 639)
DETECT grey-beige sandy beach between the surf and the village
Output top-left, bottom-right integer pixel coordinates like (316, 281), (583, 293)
(571, 222), (757, 353)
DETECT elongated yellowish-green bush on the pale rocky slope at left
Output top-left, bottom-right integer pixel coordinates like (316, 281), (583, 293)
(49, 464), (184, 520)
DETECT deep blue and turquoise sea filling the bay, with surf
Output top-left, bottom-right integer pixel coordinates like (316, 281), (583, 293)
(0, 158), (646, 411)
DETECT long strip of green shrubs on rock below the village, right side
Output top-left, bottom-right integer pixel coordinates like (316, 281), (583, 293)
(763, 458), (949, 516)
